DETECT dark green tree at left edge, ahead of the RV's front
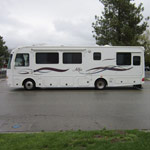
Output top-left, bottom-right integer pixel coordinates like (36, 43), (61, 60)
(0, 36), (9, 68)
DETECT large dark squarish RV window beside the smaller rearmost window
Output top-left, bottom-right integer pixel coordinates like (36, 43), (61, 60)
(117, 53), (131, 65)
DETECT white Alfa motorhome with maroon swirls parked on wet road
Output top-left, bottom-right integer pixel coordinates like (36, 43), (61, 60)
(7, 46), (145, 90)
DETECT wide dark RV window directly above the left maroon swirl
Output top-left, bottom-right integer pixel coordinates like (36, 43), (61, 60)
(36, 53), (59, 64)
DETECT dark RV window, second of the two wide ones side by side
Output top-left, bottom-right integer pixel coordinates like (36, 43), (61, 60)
(63, 53), (82, 64)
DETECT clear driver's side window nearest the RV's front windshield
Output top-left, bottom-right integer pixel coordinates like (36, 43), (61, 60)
(15, 53), (29, 67)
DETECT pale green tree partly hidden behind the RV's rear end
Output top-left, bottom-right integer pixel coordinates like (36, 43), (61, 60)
(139, 30), (150, 66)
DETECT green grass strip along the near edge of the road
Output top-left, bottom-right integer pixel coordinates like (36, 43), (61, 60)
(0, 130), (150, 150)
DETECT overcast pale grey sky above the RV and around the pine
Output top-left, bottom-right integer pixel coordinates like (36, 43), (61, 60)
(0, 0), (150, 48)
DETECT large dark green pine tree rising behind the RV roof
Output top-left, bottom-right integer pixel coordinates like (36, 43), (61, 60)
(92, 0), (149, 46)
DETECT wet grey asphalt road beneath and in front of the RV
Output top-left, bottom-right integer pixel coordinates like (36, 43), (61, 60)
(0, 79), (150, 132)
